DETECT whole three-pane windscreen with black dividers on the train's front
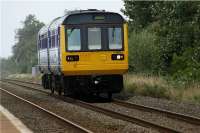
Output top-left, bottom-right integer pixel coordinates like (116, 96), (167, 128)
(65, 25), (123, 51)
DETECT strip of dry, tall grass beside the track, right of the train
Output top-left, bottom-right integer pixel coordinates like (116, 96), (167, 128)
(124, 74), (200, 103)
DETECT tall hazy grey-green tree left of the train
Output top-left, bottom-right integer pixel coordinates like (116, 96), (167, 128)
(12, 15), (44, 73)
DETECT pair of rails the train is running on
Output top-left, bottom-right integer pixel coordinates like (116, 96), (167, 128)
(1, 80), (199, 132)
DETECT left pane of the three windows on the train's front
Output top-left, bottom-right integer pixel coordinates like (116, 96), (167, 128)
(67, 28), (81, 50)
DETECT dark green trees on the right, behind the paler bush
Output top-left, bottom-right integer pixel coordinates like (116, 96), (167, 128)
(122, 0), (200, 81)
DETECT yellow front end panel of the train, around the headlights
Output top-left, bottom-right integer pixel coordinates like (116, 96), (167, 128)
(60, 24), (128, 75)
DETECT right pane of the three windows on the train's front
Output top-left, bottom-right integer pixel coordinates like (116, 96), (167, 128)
(108, 27), (122, 49)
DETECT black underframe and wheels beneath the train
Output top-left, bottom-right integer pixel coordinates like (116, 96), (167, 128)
(42, 74), (123, 99)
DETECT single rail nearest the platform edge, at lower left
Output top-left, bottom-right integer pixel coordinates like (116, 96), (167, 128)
(0, 88), (93, 133)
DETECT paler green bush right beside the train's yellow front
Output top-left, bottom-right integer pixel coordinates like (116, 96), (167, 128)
(129, 26), (159, 73)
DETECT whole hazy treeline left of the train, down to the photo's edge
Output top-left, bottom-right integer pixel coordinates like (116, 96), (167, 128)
(0, 15), (44, 76)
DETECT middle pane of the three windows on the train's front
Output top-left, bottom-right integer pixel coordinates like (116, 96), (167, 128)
(88, 27), (101, 49)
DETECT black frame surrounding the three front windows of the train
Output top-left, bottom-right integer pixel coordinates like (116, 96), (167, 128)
(65, 23), (124, 52)
